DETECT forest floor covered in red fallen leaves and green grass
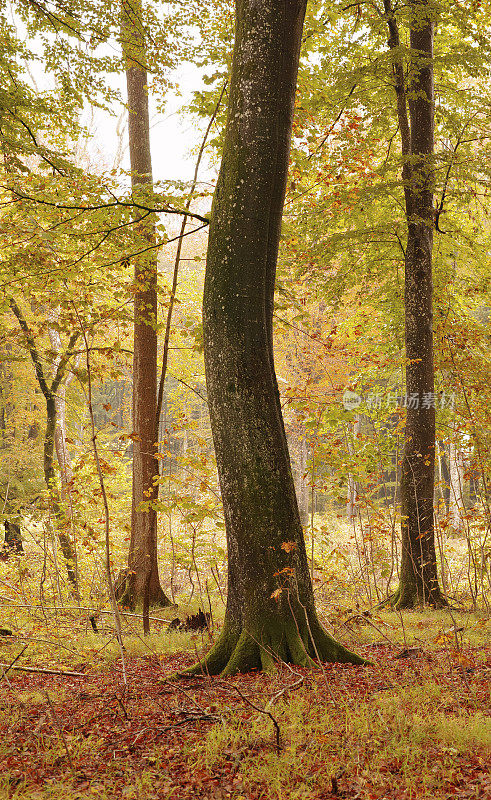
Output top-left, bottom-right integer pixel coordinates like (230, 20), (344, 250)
(0, 612), (491, 800)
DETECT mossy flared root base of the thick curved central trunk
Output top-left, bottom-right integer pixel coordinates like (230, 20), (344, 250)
(180, 619), (369, 677)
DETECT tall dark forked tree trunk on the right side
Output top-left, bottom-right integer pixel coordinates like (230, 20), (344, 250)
(384, 0), (444, 608)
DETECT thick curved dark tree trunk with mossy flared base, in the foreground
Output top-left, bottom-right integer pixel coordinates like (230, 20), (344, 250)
(188, 0), (362, 675)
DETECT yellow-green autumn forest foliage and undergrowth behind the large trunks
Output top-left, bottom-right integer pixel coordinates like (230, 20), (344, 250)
(0, 0), (491, 796)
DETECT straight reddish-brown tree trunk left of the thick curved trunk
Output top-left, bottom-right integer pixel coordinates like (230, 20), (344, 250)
(118, 0), (170, 609)
